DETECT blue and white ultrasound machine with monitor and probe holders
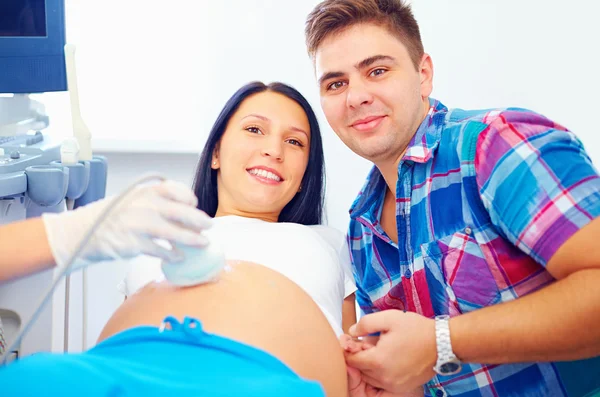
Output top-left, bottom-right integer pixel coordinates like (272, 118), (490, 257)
(0, 0), (107, 359)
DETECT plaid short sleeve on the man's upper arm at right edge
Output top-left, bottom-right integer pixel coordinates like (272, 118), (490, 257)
(475, 109), (600, 266)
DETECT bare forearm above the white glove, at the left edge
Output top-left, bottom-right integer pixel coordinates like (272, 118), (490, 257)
(0, 218), (55, 282)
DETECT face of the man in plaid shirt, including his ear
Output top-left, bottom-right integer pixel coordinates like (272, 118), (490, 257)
(315, 24), (433, 164)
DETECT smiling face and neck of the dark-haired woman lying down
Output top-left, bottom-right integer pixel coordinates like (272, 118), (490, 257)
(211, 91), (310, 221)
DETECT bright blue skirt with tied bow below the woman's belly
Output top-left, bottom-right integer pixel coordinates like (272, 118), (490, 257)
(0, 317), (325, 397)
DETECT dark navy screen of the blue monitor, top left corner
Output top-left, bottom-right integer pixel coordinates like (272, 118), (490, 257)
(0, 0), (47, 37)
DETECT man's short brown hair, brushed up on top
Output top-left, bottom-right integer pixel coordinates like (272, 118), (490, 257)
(305, 0), (424, 69)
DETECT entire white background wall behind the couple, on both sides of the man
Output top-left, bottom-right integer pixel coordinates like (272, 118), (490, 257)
(38, 0), (600, 343)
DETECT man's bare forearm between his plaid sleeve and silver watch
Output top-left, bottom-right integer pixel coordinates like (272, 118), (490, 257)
(450, 269), (600, 364)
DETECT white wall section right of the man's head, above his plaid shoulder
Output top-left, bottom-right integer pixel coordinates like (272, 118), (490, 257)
(412, 0), (600, 165)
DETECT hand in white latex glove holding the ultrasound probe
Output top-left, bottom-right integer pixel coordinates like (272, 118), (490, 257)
(42, 181), (212, 271)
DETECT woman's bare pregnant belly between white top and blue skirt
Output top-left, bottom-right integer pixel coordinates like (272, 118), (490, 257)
(99, 262), (347, 396)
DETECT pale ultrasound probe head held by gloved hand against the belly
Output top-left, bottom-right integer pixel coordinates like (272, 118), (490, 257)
(161, 238), (226, 287)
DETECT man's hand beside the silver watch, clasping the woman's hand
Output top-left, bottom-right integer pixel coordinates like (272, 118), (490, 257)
(346, 310), (437, 397)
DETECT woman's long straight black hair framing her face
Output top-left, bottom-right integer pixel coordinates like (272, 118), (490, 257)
(193, 81), (325, 225)
